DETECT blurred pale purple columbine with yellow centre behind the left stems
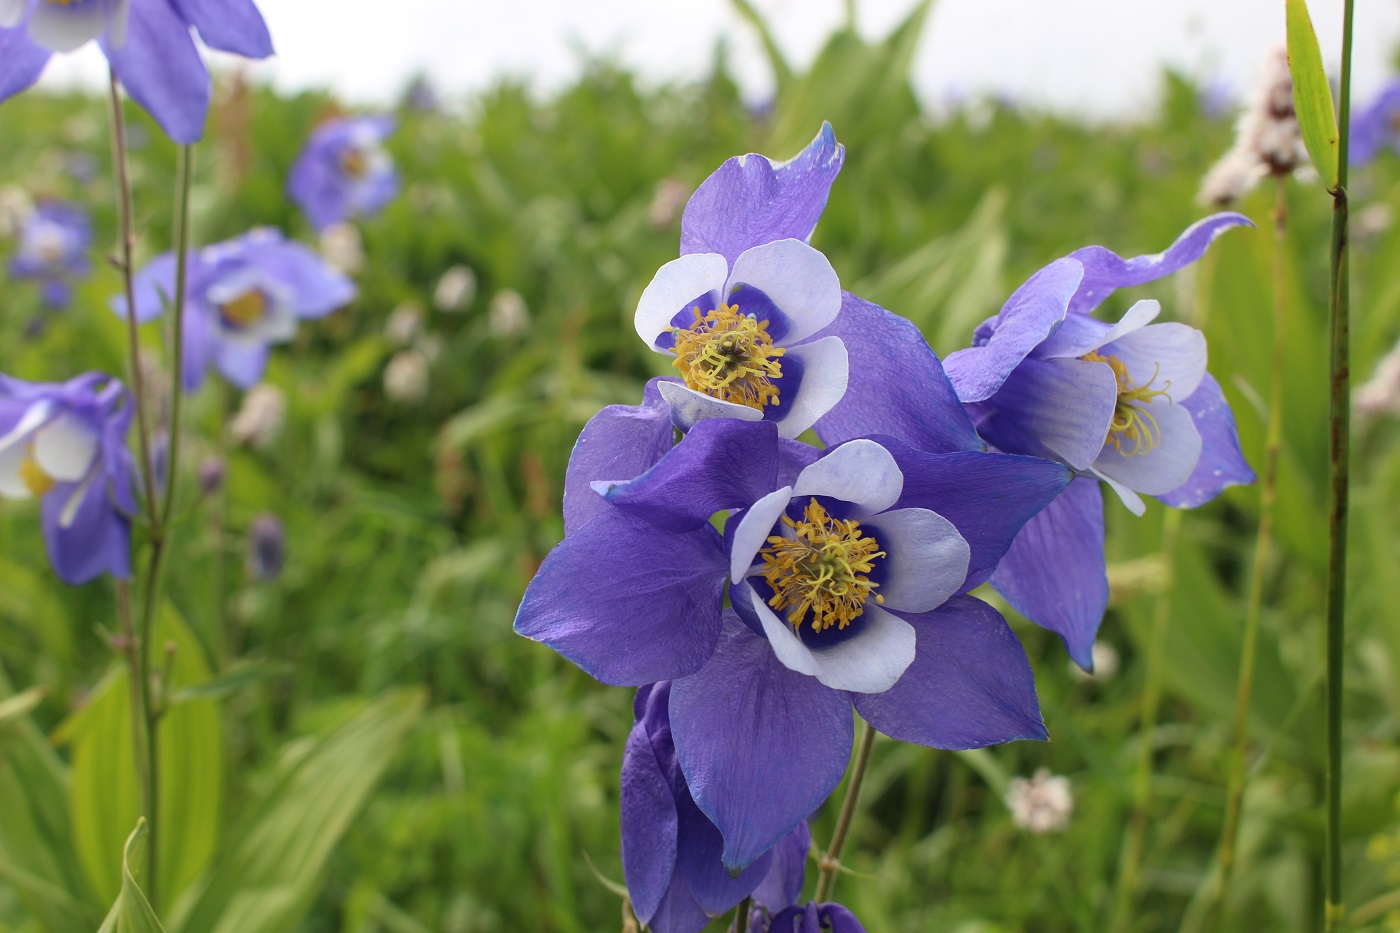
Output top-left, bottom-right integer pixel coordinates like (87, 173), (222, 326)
(113, 228), (356, 389)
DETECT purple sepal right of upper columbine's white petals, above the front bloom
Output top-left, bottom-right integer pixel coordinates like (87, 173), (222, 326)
(816, 291), (983, 454)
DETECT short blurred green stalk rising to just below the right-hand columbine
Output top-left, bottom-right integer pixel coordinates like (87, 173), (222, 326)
(1109, 509), (1182, 932)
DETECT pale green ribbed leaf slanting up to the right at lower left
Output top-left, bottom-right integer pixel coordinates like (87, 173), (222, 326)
(171, 691), (424, 933)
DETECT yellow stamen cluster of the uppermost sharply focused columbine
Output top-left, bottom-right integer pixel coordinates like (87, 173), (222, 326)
(668, 304), (785, 412)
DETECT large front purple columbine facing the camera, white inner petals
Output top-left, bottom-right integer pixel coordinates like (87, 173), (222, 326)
(515, 419), (1070, 871)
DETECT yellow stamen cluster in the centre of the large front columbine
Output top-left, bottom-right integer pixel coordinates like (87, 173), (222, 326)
(759, 499), (885, 632)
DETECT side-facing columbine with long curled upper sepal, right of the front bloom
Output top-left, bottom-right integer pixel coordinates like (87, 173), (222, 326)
(940, 213), (1254, 670)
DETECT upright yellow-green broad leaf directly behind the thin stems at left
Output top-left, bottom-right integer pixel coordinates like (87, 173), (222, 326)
(55, 605), (224, 902)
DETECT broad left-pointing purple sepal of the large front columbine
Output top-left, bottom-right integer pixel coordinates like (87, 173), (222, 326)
(515, 509), (729, 686)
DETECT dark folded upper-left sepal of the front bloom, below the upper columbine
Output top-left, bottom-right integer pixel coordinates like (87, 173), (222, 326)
(599, 417), (778, 531)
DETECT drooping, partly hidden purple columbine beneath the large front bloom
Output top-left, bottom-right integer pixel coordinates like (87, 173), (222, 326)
(622, 681), (812, 933)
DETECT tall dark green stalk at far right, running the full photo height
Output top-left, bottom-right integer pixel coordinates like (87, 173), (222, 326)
(1323, 0), (1352, 933)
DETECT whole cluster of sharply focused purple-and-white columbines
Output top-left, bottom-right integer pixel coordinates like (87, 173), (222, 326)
(515, 118), (1252, 913)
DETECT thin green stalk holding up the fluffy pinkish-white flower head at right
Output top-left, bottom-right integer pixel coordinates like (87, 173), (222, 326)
(1204, 175), (1288, 933)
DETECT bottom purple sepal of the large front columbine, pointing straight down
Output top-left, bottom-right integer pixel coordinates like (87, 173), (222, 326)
(669, 610), (854, 873)
